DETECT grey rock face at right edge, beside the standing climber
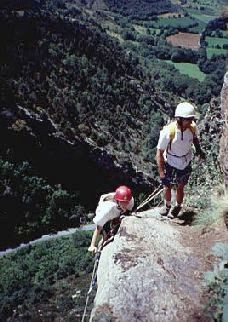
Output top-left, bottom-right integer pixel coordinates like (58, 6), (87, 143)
(219, 72), (228, 189)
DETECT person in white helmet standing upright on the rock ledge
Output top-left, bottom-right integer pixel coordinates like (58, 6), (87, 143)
(156, 102), (205, 218)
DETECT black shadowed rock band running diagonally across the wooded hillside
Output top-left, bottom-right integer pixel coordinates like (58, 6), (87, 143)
(0, 105), (155, 208)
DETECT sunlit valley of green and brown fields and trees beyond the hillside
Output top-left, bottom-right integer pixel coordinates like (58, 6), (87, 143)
(103, 4), (228, 105)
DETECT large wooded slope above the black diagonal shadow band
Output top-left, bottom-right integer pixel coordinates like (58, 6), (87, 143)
(0, 3), (165, 174)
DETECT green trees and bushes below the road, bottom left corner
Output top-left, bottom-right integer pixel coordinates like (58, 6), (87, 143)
(0, 231), (93, 321)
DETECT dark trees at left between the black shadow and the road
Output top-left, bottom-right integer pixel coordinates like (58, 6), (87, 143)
(0, 159), (84, 247)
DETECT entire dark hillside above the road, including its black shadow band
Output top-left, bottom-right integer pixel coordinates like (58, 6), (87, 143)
(0, 2), (170, 247)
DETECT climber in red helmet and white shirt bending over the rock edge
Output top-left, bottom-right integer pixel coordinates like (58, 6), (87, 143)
(88, 186), (134, 252)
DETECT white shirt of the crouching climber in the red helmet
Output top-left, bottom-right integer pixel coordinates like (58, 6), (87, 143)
(93, 193), (134, 227)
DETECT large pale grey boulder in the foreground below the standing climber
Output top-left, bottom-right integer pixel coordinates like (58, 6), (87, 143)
(90, 209), (223, 322)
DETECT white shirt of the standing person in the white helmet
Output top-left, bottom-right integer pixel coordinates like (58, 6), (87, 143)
(157, 127), (196, 170)
